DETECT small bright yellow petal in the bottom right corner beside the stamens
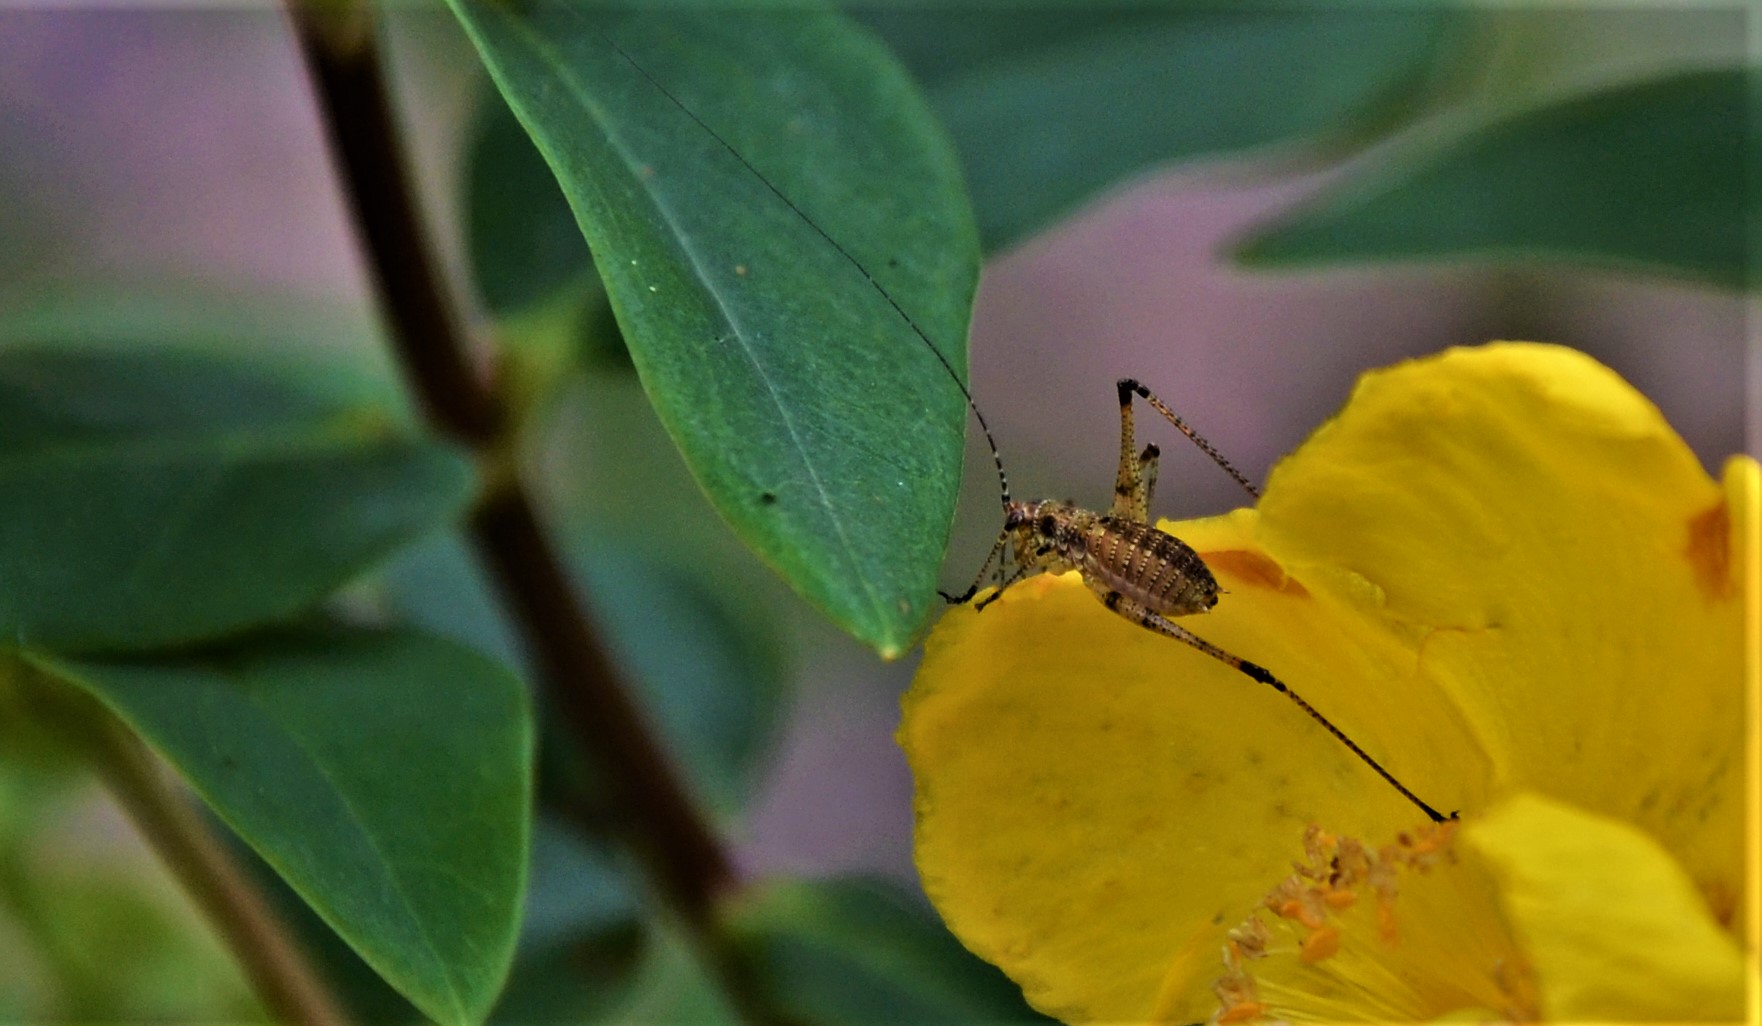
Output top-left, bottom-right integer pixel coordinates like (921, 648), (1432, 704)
(1464, 795), (1744, 1022)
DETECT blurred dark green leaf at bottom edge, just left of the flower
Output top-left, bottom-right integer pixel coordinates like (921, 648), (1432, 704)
(731, 878), (1050, 1024)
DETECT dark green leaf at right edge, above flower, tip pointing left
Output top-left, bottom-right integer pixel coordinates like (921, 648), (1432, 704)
(1237, 69), (1755, 287)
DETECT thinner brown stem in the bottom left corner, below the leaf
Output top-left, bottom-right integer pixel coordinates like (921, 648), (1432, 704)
(79, 715), (349, 1026)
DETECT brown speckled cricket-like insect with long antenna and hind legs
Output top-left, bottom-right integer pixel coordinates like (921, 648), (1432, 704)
(606, 37), (1455, 823)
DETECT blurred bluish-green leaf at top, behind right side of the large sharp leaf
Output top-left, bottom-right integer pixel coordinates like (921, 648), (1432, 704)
(867, 2), (1464, 249)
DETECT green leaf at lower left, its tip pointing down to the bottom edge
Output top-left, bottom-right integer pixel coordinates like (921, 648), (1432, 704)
(25, 628), (532, 1024)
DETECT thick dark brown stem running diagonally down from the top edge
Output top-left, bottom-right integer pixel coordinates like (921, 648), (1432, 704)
(292, 0), (735, 933)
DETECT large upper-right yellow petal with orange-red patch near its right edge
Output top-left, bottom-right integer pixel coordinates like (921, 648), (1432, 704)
(1258, 344), (1757, 922)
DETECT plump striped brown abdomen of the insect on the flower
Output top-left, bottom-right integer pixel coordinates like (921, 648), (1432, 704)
(1084, 517), (1218, 617)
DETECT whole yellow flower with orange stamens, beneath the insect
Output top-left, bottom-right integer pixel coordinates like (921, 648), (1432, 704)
(900, 344), (1758, 1022)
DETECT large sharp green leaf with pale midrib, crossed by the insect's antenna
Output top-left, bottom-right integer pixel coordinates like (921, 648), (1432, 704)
(449, 0), (978, 656)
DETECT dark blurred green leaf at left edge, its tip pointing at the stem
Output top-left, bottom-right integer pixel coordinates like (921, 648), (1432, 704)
(0, 349), (472, 651)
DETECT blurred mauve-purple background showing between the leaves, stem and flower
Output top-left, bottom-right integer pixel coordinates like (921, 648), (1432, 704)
(0, 9), (1751, 923)
